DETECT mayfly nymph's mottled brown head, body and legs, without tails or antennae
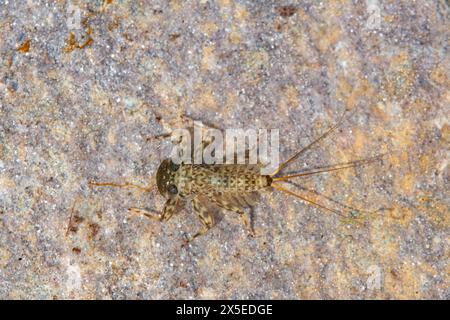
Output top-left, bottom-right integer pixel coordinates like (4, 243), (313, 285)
(151, 159), (272, 238)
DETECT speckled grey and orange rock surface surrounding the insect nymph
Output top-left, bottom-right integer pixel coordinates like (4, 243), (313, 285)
(0, 0), (450, 299)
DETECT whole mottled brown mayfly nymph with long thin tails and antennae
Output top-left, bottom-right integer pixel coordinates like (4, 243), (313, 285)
(89, 117), (383, 242)
